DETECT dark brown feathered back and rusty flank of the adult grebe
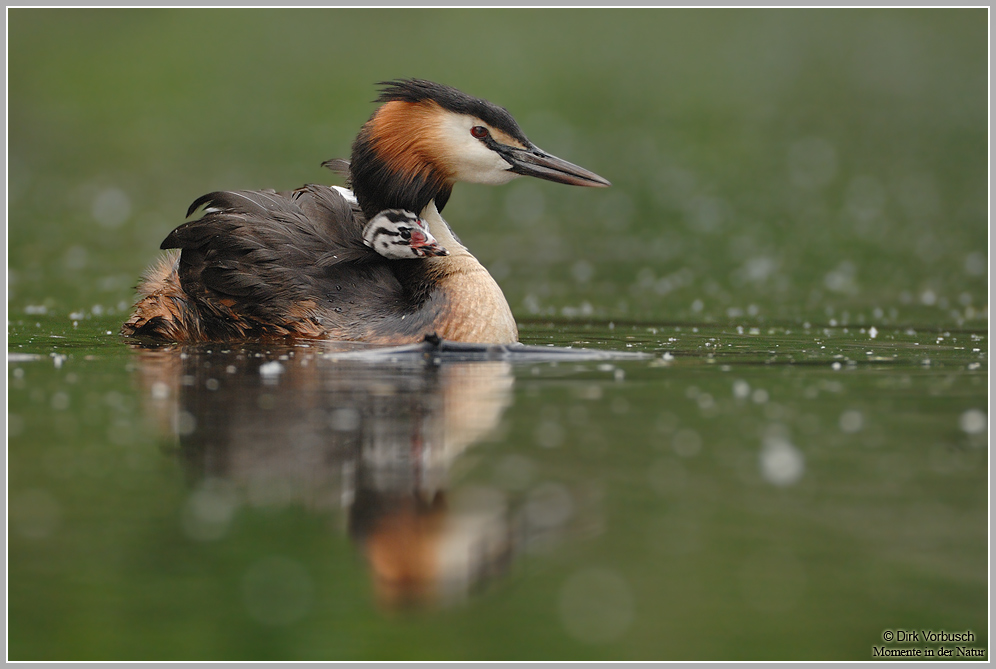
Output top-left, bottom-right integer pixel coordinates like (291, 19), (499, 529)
(123, 185), (440, 341)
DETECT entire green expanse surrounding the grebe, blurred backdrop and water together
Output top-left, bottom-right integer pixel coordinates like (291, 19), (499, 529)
(7, 10), (989, 660)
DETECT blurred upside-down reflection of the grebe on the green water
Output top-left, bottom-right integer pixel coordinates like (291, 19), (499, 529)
(127, 345), (517, 608)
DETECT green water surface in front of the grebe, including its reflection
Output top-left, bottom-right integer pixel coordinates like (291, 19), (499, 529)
(8, 318), (988, 659)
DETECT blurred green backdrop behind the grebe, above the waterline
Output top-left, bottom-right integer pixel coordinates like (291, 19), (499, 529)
(8, 9), (988, 324)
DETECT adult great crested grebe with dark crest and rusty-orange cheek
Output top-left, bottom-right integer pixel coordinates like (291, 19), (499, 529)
(121, 79), (609, 344)
